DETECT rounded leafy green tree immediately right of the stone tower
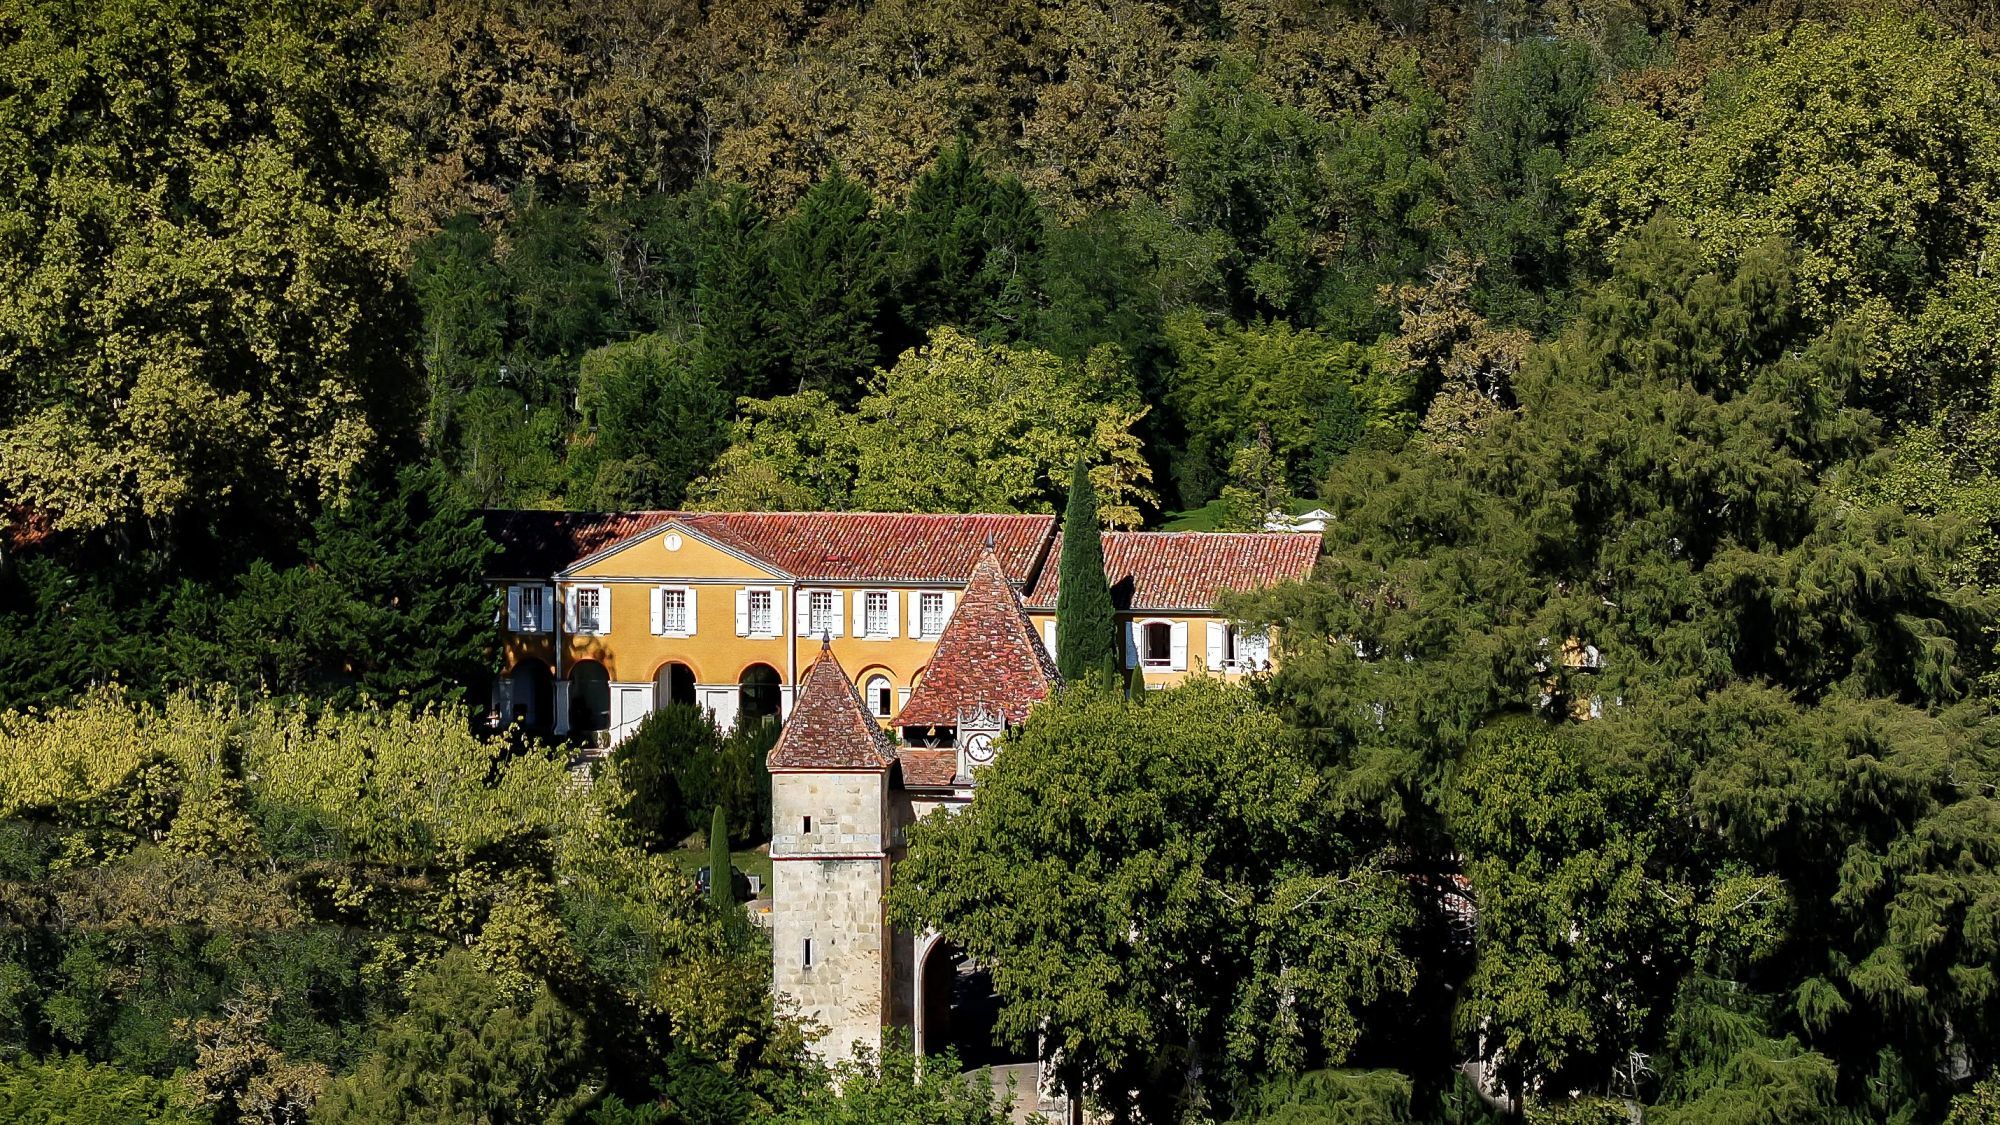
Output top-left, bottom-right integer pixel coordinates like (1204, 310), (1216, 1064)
(890, 681), (1416, 1121)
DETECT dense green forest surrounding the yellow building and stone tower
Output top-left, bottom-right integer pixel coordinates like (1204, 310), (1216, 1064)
(0, 0), (2000, 1125)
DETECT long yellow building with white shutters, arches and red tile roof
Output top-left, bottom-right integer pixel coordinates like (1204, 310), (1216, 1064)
(488, 512), (1318, 743)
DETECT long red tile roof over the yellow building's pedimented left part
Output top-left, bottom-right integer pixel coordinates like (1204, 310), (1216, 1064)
(484, 510), (1056, 585)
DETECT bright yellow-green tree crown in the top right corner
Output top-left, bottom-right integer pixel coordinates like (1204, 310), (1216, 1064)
(1566, 14), (2000, 420)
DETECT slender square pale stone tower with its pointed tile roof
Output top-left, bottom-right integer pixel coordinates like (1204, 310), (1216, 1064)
(768, 647), (896, 1061)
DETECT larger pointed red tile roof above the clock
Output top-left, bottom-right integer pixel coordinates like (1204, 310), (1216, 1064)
(896, 554), (1062, 727)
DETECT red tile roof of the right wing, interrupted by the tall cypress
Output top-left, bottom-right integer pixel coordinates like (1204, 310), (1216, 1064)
(1026, 530), (1320, 611)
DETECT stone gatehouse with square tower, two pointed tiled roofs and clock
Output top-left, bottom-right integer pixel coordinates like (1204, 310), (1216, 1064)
(770, 548), (1062, 1061)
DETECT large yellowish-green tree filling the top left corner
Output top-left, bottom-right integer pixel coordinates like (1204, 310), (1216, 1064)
(0, 0), (420, 530)
